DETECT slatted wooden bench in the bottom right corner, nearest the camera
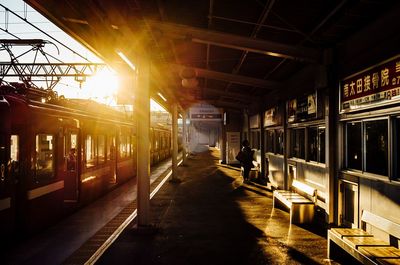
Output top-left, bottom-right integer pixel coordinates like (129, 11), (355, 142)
(328, 210), (400, 264)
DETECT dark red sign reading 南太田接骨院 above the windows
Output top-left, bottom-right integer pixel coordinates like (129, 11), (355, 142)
(340, 56), (400, 112)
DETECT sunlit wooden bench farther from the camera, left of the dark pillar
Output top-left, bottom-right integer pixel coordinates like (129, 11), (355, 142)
(273, 180), (317, 224)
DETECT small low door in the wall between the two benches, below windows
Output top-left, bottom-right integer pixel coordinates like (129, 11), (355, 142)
(339, 180), (358, 228)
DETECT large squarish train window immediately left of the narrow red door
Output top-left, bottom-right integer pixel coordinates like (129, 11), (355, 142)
(35, 134), (54, 181)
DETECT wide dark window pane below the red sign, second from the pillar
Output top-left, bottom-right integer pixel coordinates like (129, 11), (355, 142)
(365, 120), (388, 176)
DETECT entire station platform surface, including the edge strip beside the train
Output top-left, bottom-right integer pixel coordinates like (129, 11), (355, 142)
(2, 147), (339, 265)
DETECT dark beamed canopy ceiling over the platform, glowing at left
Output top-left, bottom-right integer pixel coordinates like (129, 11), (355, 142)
(25, 0), (397, 109)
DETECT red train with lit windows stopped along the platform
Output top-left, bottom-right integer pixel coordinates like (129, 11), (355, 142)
(0, 83), (171, 238)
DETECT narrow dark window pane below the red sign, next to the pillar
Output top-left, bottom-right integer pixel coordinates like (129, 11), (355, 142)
(346, 122), (362, 170)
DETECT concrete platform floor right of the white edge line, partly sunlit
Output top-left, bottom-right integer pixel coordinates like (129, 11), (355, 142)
(96, 149), (344, 265)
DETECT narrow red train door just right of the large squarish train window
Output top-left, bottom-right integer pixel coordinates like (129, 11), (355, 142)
(63, 129), (80, 202)
